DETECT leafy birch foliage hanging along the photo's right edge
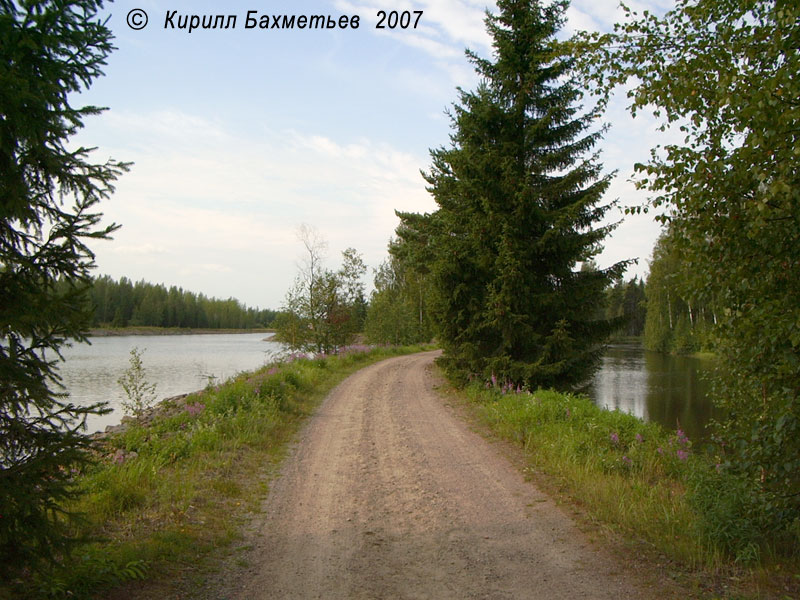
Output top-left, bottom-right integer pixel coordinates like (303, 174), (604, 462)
(579, 0), (800, 546)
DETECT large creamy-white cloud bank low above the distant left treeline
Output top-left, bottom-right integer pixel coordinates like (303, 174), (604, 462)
(78, 106), (431, 307)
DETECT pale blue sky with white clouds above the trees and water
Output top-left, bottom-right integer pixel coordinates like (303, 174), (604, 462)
(73, 0), (673, 309)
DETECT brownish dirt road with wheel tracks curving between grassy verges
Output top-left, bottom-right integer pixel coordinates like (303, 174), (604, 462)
(225, 353), (652, 600)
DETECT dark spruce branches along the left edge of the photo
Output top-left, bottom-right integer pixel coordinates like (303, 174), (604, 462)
(0, 0), (127, 581)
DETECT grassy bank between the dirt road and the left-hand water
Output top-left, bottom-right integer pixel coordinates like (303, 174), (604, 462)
(15, 347), (424, 598)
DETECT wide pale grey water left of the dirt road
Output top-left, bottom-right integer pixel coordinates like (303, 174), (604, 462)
(59, 333), (281, 431)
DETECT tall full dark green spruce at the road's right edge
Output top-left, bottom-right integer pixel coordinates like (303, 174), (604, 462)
(398, 0), (629, 388)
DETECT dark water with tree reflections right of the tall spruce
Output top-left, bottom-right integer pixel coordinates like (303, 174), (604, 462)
(587, 344), (717, 441)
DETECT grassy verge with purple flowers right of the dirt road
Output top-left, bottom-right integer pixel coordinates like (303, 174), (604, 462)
(457, 385), (800, 598)
